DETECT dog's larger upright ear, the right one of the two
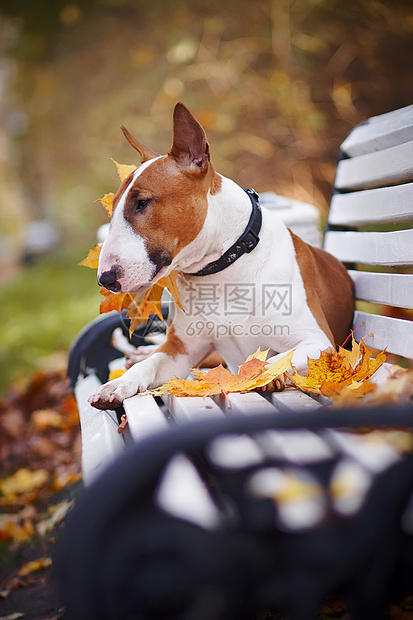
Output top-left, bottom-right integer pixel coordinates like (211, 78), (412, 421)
(170, 102), (210, 172)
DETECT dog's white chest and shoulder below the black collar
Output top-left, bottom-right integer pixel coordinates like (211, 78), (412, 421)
(173, 213), (318, 365)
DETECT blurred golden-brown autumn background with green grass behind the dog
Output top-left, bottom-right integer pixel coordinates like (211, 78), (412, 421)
(0, 0), (413, 387)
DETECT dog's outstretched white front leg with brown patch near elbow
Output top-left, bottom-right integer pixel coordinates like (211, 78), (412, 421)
(89, 326), (210, 409)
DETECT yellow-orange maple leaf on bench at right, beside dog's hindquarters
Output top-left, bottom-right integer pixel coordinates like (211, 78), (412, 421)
(286, 337), (386, 398)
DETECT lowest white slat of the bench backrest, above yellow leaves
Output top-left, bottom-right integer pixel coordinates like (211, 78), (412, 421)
(353, 310), (413, 358)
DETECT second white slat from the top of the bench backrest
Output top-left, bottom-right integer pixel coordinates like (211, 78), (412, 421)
(335, 141), (413, 190)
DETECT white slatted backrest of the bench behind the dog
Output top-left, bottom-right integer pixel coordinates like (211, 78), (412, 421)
(324, 105), (413, 358)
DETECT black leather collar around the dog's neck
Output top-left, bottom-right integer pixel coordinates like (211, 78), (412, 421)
(188, 188), (262, 276)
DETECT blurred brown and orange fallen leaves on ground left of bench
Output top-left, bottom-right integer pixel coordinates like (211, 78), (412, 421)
(0, 367), (81, 550)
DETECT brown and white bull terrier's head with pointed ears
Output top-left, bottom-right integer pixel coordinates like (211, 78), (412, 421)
(98, 103), (218, 293)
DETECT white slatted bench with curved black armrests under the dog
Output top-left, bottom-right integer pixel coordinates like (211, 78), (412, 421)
(62, 106), (413, 620)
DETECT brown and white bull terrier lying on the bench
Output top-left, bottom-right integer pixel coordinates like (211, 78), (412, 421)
(90, 103), (353, 409)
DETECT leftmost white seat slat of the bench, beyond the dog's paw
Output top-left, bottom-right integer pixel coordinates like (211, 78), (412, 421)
(75, 375), (125, 485)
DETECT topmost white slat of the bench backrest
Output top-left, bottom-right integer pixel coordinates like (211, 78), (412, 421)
(341, 105), (413, 157)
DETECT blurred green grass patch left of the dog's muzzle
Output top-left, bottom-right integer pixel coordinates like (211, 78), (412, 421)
(0, 249), (100, 393)
